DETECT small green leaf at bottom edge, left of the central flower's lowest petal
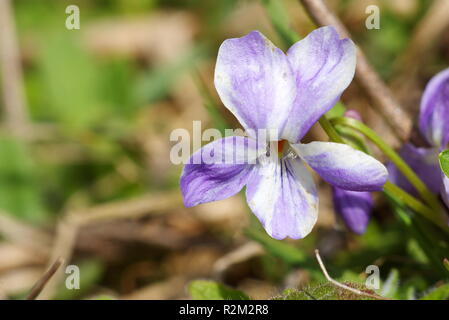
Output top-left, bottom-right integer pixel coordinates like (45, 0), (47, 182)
(188, 280), (250, 300)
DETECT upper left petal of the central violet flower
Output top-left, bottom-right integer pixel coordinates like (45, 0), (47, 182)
(215, 31), (296, 140)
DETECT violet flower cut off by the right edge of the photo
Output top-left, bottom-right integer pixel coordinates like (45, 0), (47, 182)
(388, 68), (449, 207)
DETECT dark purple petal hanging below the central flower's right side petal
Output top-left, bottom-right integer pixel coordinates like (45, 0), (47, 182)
(332, 187), (373, 234)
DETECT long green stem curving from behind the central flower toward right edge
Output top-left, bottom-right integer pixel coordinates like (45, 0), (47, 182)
(331, 118), (443, 221)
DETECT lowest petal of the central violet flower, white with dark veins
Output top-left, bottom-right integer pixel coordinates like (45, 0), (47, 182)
(246, 156), (318, 239)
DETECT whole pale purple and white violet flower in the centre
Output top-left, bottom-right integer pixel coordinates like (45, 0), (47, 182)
(180, 27), (388, 239)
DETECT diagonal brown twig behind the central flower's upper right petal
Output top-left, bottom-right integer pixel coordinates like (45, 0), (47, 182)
(300, 0), (412, 141)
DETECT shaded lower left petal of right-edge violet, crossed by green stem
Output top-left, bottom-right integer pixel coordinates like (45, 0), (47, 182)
(387, 143), (442, 195)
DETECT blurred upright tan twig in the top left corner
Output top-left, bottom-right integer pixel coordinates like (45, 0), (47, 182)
(0, 0), (28, 136)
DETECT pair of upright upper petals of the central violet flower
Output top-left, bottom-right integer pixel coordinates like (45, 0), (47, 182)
(215, 26), (356, 143)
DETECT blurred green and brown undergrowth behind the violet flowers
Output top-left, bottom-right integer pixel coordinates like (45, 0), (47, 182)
(0, 0), (449, 299)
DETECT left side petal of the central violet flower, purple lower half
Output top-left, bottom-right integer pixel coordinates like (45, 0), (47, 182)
(180, 136), (257, 207)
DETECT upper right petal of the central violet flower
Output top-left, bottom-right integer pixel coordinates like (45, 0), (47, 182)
(282, 26), (356, 143)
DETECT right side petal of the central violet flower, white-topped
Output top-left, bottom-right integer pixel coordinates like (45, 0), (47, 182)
(291, 141), (388, 191)
